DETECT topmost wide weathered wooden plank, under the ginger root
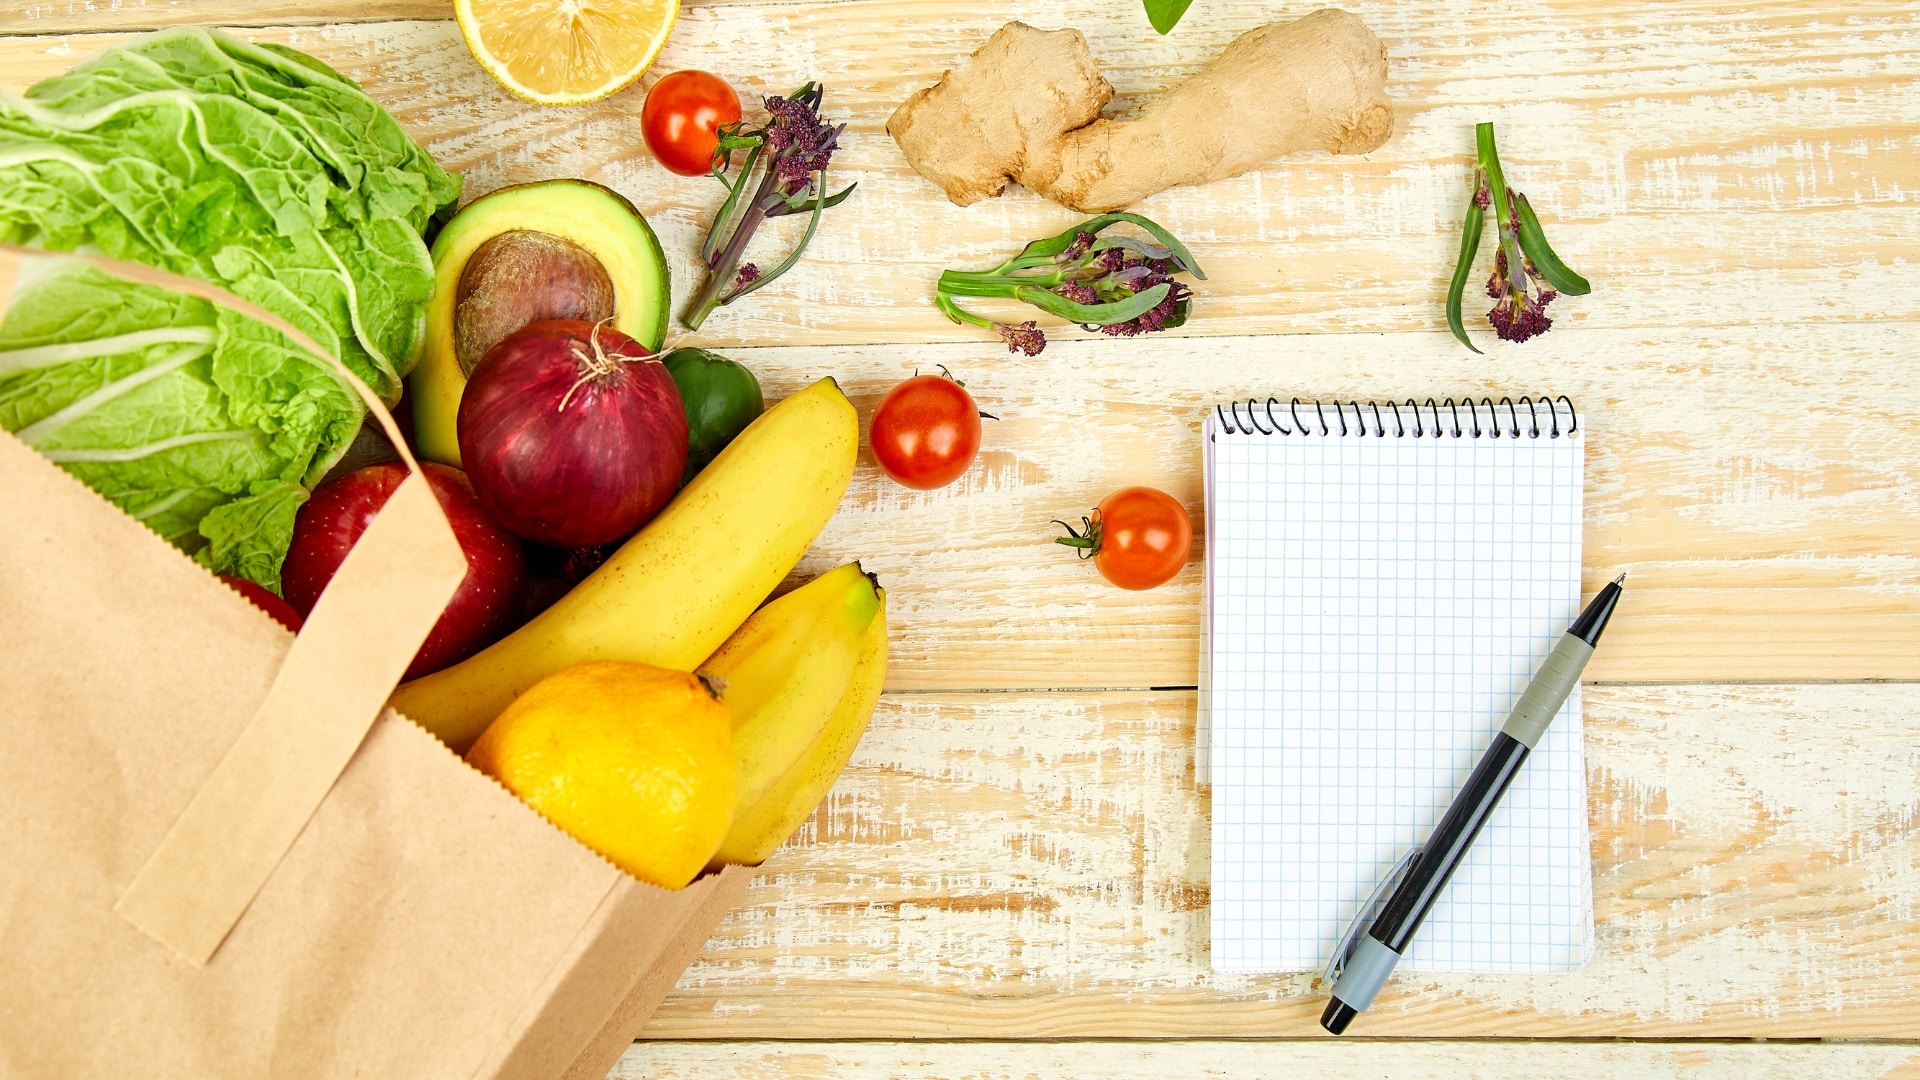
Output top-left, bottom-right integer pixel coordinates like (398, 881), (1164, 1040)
(0, 0), (1920, 349)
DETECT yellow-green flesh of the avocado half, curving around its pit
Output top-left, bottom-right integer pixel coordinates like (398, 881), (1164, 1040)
(407, 181), (672, 467)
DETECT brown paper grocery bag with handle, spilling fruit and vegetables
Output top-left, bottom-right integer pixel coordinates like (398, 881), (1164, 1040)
(0, 248), (749, 1078)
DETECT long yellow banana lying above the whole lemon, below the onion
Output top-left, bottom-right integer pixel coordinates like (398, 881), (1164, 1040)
(392, 379), (860, 751)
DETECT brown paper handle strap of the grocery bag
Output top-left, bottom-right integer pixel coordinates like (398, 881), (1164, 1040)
(0, 244), (467, 965)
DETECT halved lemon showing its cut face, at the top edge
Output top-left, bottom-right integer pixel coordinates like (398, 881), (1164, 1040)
(453, 0), (680, 106)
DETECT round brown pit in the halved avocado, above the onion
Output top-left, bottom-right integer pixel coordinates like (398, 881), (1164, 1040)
(453, 229), (614, 375)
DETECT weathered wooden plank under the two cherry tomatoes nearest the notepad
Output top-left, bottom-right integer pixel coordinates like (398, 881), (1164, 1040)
(737, 323), (1920, 688)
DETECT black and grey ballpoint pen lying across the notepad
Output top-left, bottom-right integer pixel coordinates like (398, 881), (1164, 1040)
(1321, 575), (1626, 1036)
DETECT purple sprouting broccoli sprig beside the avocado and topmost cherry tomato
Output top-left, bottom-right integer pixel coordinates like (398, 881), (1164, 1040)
(684, 83), (854, 331)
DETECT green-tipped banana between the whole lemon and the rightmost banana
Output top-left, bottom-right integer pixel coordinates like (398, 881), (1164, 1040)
(701, 563), (879, 805)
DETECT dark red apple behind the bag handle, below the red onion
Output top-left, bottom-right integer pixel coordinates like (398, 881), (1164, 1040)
(280, 461), (526, 678)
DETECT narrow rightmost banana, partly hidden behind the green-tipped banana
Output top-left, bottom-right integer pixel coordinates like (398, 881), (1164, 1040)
(712, 590), (887, 867)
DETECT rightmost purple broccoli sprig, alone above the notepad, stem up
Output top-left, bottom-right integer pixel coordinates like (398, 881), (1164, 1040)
(1446, 123), (1592, 352)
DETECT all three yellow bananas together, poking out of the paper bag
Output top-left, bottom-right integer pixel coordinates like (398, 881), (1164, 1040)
(392, 379), (887, 865)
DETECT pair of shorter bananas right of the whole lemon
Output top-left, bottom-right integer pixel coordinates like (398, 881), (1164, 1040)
(701, 563), (887, 865)
